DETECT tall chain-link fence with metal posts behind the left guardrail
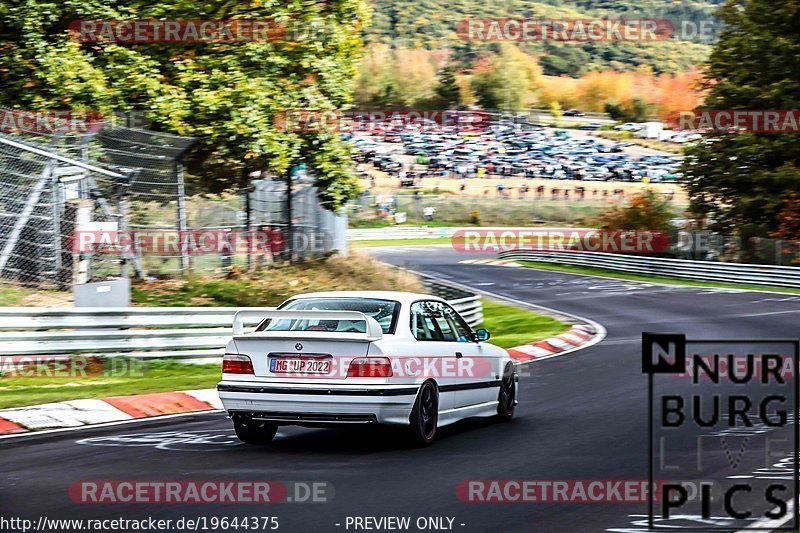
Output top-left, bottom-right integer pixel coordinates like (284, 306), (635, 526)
(0, 118), (346, 289)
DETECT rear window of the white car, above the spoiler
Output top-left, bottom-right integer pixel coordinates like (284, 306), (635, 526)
(256, 298), (400, 334)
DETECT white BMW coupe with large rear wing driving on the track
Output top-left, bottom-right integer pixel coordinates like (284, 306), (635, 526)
(217, 291), (517, 445)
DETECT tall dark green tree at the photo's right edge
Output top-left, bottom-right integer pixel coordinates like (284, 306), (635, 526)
(683, 0), (800, 236)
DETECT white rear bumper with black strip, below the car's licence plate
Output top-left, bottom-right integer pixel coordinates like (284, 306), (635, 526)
(217, 381), (419, 426)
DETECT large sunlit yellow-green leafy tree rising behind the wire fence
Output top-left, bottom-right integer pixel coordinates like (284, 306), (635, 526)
(0, 0), (369, 209)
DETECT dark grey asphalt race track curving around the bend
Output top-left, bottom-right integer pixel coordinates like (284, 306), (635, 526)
(0, 247), (800, 532)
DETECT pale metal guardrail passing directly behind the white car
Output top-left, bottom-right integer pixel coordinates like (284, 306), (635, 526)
(0, 287), (483, 361)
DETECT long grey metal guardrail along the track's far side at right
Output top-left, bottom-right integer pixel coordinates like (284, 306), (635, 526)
(499, 250), (800, 288)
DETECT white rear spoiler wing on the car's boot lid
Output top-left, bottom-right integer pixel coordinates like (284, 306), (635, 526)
(233, 310), (383, 341)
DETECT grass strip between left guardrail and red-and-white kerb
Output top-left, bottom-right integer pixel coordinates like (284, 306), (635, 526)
(0, 359), (221, 408)
